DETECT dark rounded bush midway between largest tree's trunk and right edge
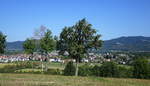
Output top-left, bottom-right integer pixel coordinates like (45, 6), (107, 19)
(100, 62), (119, 77)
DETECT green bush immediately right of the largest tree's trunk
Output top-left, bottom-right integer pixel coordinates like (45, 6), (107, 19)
(79, 64), (92, 76)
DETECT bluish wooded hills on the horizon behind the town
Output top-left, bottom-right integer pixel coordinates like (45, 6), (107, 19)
(7, 36), (150, 51)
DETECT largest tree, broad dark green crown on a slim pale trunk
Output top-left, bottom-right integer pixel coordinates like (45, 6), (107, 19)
(59, 19), (102, 76)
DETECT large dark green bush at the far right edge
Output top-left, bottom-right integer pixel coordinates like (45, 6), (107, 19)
(133, 58), (150, 79)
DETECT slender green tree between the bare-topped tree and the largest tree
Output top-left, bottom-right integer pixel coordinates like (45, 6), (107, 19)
(40, 29), (56, 71)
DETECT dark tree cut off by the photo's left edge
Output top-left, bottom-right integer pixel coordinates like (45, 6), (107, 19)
(0, 32), (6, 54)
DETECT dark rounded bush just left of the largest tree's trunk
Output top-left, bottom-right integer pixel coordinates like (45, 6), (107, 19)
(64, 61), (76, 76)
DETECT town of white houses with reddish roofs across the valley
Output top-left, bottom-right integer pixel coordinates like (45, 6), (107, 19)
(0, 51), (129, 64)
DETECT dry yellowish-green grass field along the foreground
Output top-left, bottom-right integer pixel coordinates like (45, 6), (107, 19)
(0, 74), (150, 86)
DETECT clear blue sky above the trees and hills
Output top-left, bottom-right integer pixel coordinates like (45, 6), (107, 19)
(0, 0), (150, 42)
